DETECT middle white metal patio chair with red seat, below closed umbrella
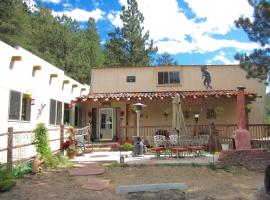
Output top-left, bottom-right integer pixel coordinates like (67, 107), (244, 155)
(169, 135), (188, 158)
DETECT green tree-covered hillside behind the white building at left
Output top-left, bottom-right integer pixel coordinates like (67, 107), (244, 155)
(0, 0), (104, 84)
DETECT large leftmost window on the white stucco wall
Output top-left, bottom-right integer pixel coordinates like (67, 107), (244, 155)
(8, 90), (31, 121)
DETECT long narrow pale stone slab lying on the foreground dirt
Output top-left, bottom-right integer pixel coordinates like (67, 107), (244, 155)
(115, 183), (187, 194)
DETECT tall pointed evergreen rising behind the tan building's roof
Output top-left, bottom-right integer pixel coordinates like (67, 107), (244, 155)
(105, 0), (157, 66)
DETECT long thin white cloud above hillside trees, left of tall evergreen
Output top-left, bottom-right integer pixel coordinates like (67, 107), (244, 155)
(52, 8), (105, 22)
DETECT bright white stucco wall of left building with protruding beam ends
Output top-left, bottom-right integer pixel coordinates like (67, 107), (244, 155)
(0, 41), (89, 133)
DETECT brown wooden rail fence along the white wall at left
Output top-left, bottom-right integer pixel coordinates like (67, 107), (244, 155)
(0, 125), (89, 170)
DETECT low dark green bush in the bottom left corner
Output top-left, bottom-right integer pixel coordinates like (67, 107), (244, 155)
(0, 167), (16, 192)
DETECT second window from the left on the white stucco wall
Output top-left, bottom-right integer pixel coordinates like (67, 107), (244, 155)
(50, 99), (62, 125)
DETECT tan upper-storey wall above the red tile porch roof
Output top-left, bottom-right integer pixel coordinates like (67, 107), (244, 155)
(91, 65), (265, 95)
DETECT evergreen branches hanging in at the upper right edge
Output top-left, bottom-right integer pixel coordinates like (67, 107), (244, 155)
(235, 0), (270, 82)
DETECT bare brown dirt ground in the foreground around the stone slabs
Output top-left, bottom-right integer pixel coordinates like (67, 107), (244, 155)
(0, 166), (270, 200)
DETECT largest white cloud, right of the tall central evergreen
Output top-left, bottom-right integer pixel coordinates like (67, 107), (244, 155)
(107, 0), (257, 54)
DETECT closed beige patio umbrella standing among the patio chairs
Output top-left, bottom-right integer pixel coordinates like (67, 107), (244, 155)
(172, 94), (187, 135)
